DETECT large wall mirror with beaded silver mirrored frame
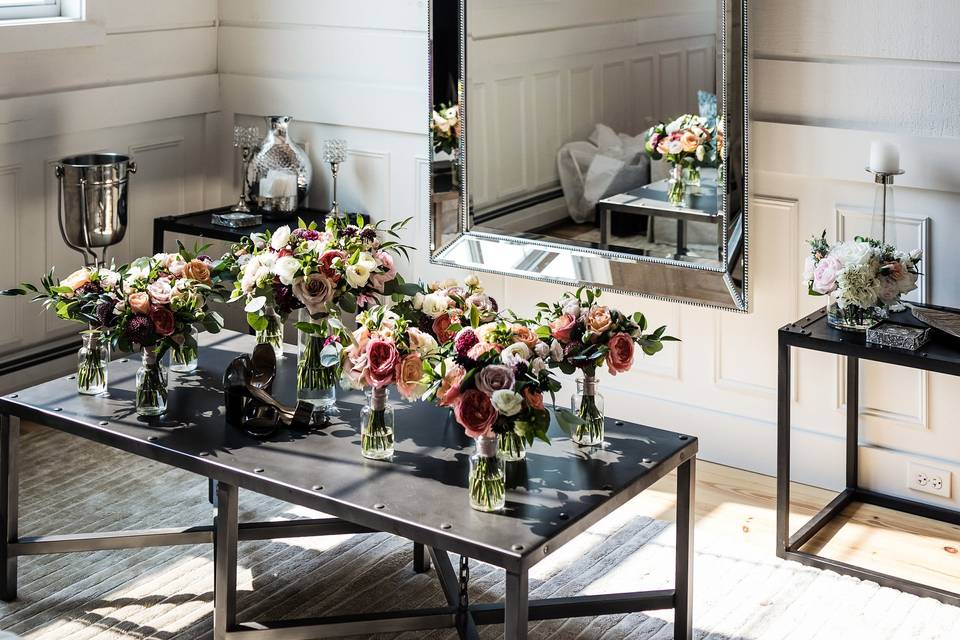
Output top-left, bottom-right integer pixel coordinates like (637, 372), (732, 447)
(430, 0), (748, 311)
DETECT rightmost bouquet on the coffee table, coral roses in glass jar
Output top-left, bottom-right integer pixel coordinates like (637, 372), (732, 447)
(537, 287), (677, 447)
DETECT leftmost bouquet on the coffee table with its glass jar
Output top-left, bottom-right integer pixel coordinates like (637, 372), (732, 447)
(0, 267), (122, 395)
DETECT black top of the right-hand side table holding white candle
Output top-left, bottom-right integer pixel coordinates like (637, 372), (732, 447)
(779, 305), (960, 376)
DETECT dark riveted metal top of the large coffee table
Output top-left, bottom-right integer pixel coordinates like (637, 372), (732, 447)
(0, 331), (698, 569)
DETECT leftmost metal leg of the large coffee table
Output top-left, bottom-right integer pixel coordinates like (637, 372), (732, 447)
(0, 415), (20, 602)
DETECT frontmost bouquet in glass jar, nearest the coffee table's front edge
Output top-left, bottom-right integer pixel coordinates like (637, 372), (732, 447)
(424, 314), (579, 511)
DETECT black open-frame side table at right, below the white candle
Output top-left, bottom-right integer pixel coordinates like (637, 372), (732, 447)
(777, 310), (960, 606)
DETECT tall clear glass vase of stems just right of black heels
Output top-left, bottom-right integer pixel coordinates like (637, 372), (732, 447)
(297, 309), (340, 415)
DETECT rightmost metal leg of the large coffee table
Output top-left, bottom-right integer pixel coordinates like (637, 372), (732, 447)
(673, 458), (697, 640)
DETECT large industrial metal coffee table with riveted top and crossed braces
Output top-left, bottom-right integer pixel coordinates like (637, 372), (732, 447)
(0, 331), (697, 640)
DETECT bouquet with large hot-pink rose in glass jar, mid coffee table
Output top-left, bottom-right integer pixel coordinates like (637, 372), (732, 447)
(343, 306), (437, 460)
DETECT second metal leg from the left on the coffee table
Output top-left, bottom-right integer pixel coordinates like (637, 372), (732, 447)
(213, 482), (240, 640)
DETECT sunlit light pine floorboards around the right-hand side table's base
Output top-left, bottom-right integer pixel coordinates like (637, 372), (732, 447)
(638, 462), (960, 593)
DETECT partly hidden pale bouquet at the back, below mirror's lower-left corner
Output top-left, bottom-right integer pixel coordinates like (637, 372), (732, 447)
(394, 274), (498, 344)
